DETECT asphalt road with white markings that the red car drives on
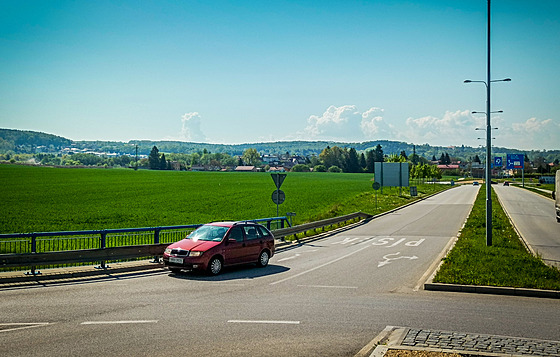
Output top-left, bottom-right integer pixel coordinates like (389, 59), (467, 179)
(0, 186), (560, 356)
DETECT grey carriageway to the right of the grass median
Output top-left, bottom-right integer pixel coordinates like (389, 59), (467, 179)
(492, 185), (560, 267)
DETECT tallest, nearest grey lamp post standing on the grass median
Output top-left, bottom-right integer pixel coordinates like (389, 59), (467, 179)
(464, 0), (511, 246)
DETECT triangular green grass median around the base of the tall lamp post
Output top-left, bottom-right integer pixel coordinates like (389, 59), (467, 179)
(434, 187), (560, 290)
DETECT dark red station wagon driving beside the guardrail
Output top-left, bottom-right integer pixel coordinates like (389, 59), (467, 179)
(163, 222), (274, 275)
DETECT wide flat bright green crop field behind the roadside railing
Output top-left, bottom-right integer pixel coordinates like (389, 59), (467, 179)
(0, 165), (445, 233)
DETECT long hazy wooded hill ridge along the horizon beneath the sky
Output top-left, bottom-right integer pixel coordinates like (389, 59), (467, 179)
(0, 129), (560, 162)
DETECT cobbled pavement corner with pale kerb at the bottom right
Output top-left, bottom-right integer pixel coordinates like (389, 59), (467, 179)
(356, 326), (560, 357)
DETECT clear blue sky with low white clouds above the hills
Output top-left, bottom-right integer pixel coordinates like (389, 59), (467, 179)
(0, 0), (560, 150)
